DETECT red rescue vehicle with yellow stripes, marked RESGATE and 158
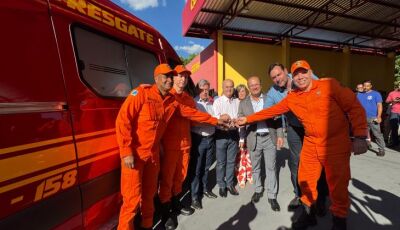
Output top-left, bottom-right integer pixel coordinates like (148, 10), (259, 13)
(0, 0), (180, 229)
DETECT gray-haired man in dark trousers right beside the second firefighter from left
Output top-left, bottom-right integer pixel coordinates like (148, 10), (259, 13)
(189, 79), (217, 209)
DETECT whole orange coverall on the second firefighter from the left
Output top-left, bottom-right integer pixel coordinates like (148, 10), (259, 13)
(159, 89), (196, 203)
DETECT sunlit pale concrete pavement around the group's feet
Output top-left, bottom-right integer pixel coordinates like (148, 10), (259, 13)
(169, 144), (400, 230)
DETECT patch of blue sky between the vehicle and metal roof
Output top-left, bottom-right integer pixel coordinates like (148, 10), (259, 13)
(112, 0), (211, 57)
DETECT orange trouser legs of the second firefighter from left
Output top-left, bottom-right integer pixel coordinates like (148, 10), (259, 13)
(158, 148), (190, 203)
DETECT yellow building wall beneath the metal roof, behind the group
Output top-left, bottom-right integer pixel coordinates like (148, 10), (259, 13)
(218, 36), (394, 95)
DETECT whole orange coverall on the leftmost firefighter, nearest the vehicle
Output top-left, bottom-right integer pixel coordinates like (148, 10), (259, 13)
(116, 85), (217, 229)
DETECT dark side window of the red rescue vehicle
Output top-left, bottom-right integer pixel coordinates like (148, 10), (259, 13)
(73, 27), (158, 97)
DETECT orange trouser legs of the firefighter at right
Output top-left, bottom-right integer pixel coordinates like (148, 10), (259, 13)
(298, 146), (350, 217)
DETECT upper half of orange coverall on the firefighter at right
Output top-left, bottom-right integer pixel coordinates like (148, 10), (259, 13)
(247, 78), (367, 154)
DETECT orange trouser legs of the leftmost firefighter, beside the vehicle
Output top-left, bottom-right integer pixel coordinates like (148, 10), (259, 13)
(118, 158), (160, 230)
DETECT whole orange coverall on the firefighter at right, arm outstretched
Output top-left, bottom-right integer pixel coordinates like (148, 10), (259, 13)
(247, 78), (367, 217)
